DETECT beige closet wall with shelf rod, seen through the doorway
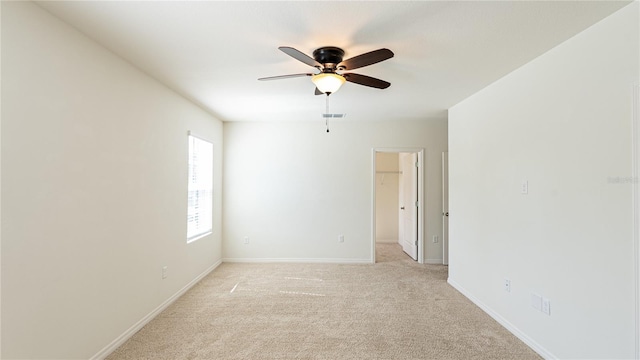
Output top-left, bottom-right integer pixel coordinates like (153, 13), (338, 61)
(376, 152), (400, 243)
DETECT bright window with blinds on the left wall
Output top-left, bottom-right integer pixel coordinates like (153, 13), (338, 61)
(187, 134), (213, 242)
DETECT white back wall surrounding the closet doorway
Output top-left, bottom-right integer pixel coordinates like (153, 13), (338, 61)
(223, 119), (447, 262)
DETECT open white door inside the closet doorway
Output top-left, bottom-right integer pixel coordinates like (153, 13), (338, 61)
(398, 153), (418, 260)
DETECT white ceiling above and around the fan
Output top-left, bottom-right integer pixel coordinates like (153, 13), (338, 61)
(38, 1), (629, 121)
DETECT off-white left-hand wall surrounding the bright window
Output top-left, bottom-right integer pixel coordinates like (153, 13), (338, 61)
(2, 2), (222, 359)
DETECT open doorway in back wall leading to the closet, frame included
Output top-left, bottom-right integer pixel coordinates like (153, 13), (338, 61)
(371, 148), (424, 264)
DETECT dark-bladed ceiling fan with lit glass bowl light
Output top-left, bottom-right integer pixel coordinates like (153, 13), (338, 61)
(258, 46), (393, 96)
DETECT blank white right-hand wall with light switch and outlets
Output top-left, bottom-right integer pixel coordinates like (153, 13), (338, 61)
(449, 2), (639, 359)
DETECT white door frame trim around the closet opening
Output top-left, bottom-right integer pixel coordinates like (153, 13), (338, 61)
(370, 148), (425, 264)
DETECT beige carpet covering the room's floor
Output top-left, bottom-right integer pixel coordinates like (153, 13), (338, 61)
(108, 244), (540, 360)
